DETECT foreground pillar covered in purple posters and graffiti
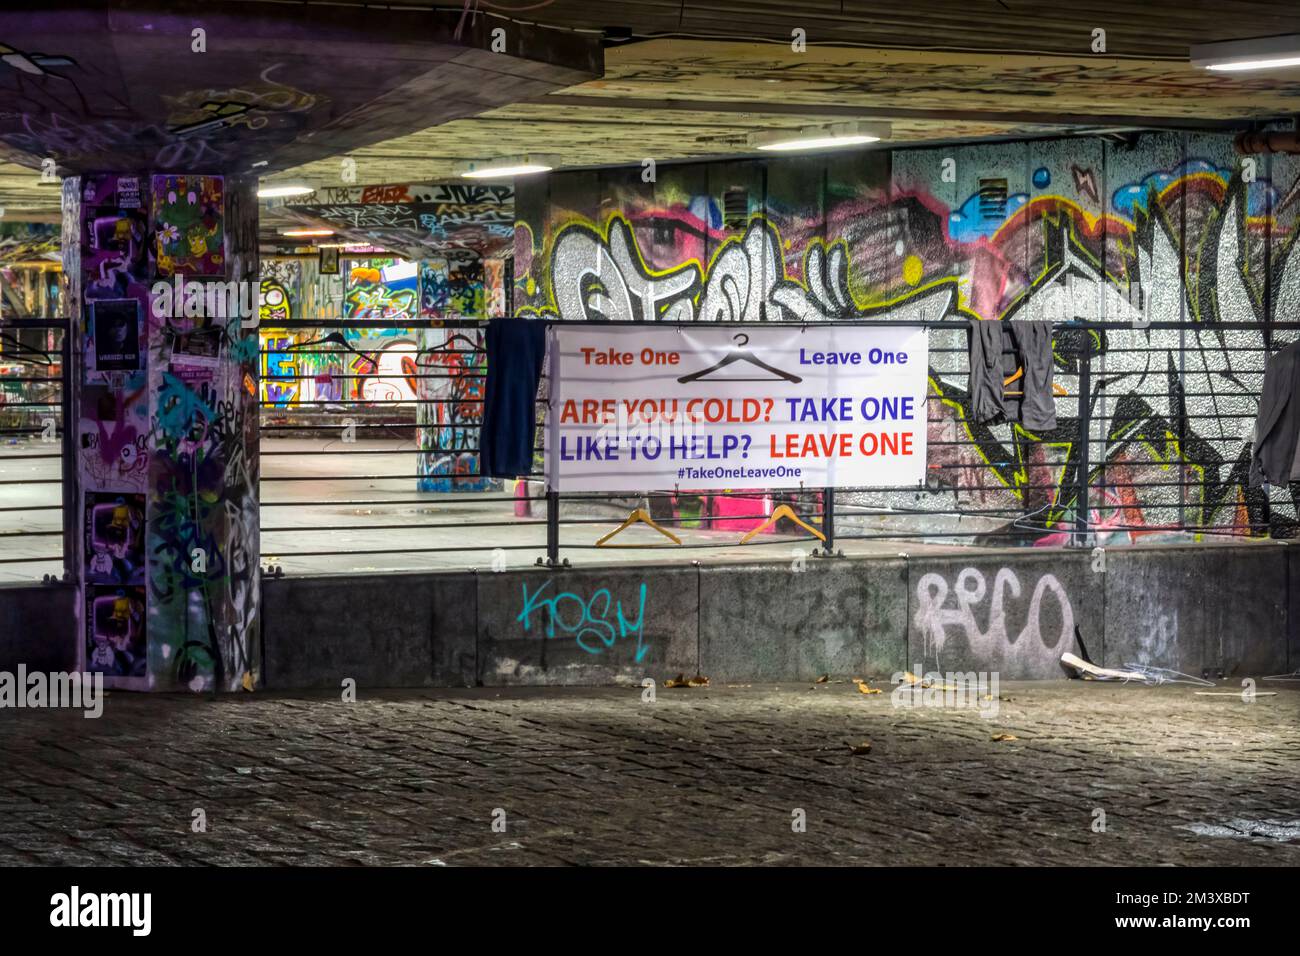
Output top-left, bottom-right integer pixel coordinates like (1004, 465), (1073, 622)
(64, 172), (261, 691)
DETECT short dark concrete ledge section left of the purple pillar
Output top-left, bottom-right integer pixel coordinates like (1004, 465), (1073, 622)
(0, 584), (81, 672)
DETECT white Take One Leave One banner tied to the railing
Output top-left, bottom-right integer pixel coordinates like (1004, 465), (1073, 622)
(546, 324), (928, 492)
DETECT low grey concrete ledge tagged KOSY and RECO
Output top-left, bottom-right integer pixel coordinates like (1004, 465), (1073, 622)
(244, 544), (1300, 689)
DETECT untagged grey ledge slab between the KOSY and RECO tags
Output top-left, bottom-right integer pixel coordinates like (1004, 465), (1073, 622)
(699, 557), (907, 683)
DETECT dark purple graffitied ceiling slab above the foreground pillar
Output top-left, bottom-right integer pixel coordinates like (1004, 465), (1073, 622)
(0, 0), (602, 216)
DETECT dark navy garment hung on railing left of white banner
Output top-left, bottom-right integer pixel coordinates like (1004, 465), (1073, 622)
(478, 319), (546, 477)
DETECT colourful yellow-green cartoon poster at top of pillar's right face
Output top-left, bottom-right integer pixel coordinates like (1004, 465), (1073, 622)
(152, 176), (226, 276)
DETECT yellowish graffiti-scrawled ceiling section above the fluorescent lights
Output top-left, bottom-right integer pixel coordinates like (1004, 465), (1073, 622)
(269, 39), (1300, 195)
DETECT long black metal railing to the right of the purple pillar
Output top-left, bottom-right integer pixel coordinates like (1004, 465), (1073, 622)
(253, 319), (1300, 570)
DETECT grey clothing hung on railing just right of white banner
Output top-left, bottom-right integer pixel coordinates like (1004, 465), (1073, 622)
(970, 320), (1056, 432)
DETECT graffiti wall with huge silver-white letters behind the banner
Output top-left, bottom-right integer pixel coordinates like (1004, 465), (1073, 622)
(514, 134), (1300, 544)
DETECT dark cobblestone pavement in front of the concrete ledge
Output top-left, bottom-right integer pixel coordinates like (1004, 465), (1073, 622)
(0, 682), (1300, 865)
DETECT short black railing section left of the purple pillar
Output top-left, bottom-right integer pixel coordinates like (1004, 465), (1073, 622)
(0, 319), (75, 583)
